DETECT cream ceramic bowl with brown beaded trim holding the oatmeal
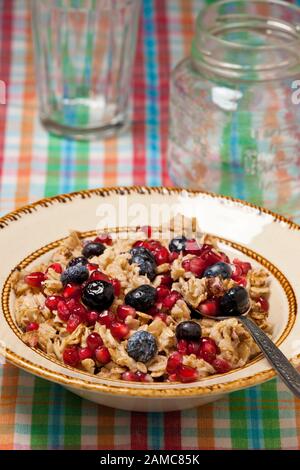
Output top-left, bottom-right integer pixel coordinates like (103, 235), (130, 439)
(0, 187), (300, 411)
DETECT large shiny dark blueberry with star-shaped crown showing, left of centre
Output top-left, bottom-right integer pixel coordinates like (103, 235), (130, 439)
(81, 281), (115, 311)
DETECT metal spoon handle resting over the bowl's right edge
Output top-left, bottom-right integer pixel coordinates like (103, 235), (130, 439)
(239, 316), (300, 398)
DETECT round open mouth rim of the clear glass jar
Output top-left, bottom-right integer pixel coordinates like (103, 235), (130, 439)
(196, 0), (300, 50)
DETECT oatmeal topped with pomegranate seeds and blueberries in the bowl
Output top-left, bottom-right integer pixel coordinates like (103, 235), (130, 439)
(12, 227), (271, 383)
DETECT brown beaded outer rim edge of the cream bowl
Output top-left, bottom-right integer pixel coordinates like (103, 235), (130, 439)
(0, 186), (300, 398)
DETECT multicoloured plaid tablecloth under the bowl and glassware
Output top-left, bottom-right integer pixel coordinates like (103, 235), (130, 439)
(0, 0), (300, 449)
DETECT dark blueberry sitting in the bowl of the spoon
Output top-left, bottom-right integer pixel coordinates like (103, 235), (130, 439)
(219, 286), (250, 317)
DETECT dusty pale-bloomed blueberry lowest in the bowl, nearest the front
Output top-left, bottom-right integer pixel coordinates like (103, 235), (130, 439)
(127, 331), (157, 363)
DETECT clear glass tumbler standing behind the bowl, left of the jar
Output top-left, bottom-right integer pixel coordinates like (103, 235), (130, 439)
(31, 0), (140, 140)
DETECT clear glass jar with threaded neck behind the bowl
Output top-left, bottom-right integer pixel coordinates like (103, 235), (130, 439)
(168, 0), (300, 216)
